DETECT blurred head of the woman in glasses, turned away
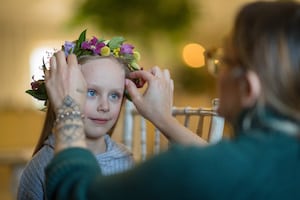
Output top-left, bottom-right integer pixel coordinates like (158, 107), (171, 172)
(219, 2), (300, 120)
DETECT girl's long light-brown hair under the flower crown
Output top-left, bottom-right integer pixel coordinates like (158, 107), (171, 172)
(33, 55), (130, 156)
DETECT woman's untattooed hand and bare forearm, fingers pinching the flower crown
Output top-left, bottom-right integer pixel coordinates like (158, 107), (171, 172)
(126, 67), (206, 145)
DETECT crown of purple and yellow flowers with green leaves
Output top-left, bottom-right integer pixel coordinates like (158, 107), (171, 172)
(26, 30), (143, 104)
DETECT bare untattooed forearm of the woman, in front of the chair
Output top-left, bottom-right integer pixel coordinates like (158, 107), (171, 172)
(155, 117), (207, 145)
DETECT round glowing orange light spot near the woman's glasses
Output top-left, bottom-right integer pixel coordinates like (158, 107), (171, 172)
(182, 43), (205, 68)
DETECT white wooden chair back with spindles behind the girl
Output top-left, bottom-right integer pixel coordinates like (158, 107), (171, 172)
(122, 99), (224, 161)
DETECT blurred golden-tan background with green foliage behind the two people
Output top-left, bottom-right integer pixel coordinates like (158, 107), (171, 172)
(0, 0), (262, 200)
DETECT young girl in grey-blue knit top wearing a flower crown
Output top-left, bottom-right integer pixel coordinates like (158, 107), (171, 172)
(18, 31), (142, 200)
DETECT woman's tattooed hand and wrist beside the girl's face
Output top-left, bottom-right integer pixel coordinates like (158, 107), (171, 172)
(45, 51), (86, 152)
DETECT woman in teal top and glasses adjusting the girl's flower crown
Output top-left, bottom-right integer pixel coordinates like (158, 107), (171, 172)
(46, 1), (300, 199)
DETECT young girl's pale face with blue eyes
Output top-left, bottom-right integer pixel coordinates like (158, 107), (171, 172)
(82, 57), (125, 138)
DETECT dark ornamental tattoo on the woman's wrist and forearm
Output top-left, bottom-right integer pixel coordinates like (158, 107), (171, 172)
(54, 96), (85, 146)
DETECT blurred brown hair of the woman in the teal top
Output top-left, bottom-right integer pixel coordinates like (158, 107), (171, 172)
(224, 1), (300, 122)
